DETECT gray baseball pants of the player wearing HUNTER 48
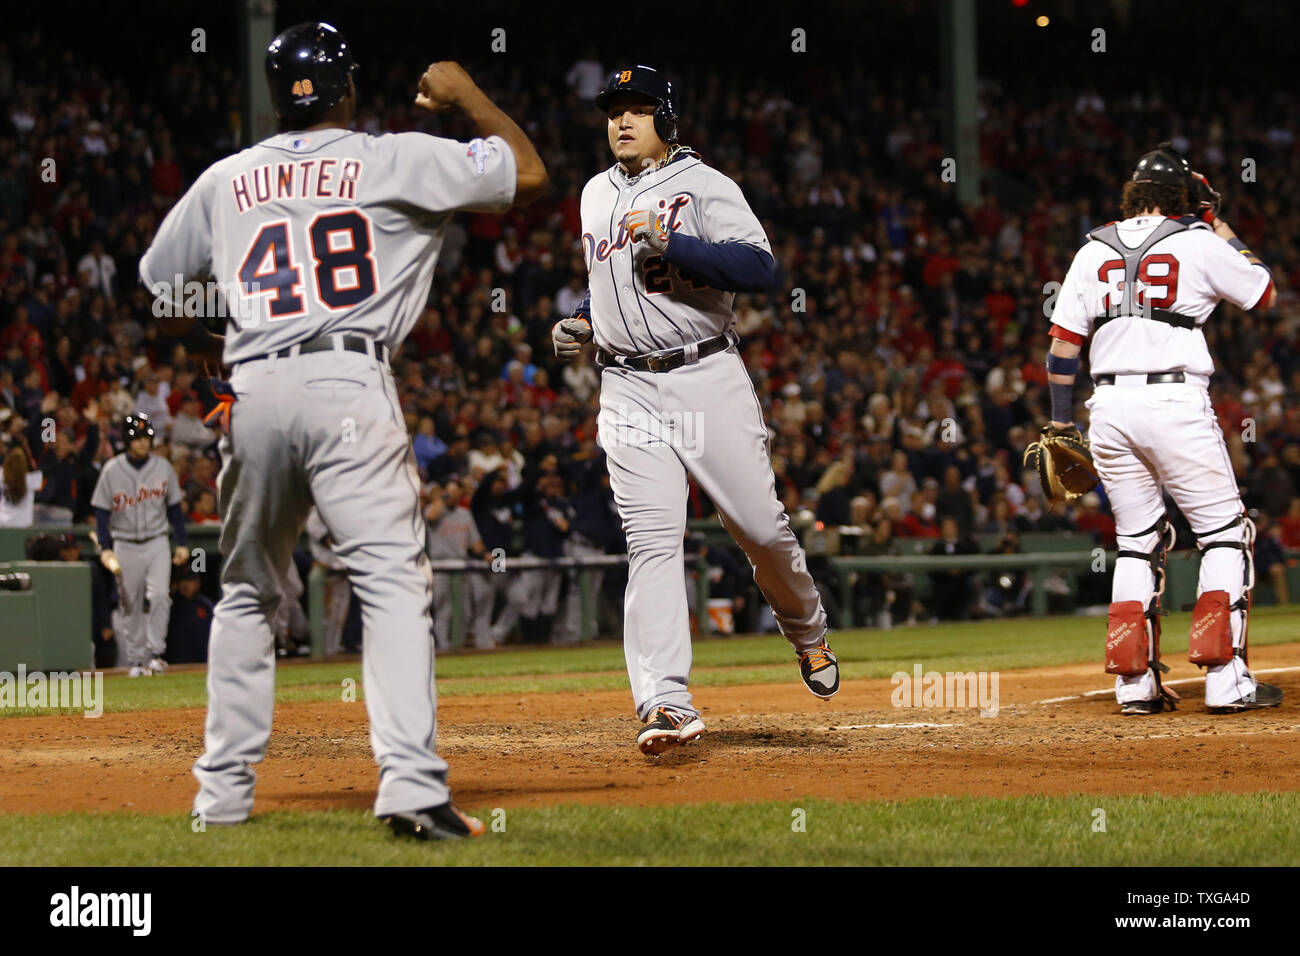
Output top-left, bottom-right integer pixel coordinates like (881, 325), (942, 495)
(194, 350), (450, 823)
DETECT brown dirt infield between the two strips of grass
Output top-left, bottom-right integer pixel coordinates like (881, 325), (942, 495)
(0, 644), (1300, 813)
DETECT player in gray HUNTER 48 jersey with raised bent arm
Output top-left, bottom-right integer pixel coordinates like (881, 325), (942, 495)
(140, 23), (547, 839)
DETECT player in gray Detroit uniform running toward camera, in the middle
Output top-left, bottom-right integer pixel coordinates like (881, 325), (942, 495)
(551, 65), (840, 756)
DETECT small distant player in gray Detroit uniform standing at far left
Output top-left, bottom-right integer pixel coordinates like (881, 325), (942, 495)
(91, 412), (190, 678)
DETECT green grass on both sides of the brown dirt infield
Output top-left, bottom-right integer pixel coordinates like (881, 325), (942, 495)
(0, 607), (1300, 866)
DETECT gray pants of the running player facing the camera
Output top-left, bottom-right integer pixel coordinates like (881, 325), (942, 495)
(598, 343), (827, 721)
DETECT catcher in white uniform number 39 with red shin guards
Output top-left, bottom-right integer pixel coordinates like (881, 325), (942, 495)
(1048, 143), (1282, 715)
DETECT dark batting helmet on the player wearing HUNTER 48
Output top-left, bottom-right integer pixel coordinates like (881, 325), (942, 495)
(267, 23), (356, 120)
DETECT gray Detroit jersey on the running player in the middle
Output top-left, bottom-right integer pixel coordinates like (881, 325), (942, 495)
(581, 153), (771, 355)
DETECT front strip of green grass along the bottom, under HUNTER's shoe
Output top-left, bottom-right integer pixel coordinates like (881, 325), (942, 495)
(0, 793), (1300, 866)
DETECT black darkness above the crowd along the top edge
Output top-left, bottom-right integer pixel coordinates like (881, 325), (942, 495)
(5, 0), (1300, 96)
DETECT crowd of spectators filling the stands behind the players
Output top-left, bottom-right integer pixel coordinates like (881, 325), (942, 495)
(0, 33), (1300, 658)
